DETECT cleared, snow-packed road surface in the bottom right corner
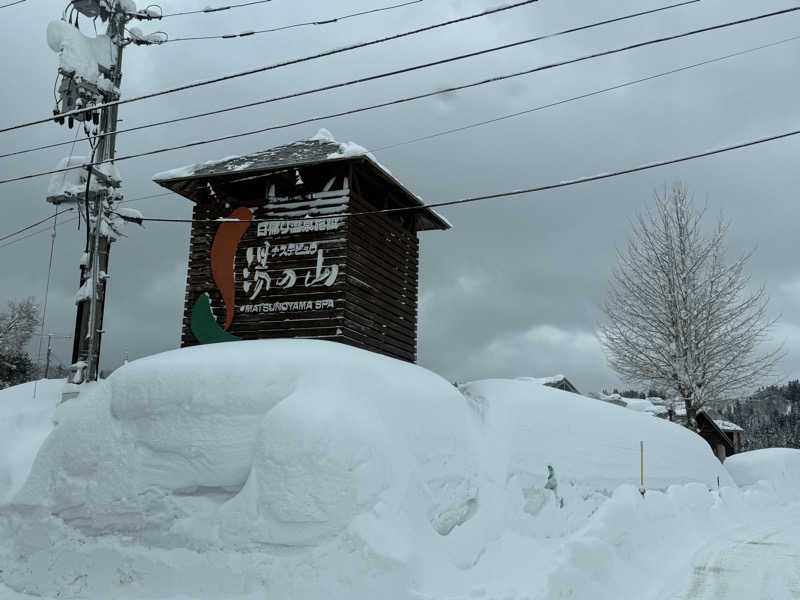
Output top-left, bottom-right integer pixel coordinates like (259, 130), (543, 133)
(661, 510), (800, 600)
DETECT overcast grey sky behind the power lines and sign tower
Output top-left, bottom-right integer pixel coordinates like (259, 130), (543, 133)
(0, 0), (800, 391)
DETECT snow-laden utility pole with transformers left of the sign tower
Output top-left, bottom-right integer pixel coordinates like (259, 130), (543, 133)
(47, 0), (166, 383)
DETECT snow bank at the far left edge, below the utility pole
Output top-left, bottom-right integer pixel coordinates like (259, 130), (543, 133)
(0, 379), (64, 504)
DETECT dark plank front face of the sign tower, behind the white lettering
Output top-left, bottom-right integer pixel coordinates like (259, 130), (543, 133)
(181, 169), (349, 346)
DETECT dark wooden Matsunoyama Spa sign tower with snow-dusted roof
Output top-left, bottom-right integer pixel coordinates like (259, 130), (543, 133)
(154, 130), (450, 361)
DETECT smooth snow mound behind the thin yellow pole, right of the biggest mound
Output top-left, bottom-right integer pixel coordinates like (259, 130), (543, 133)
(461, 379), (733, 493)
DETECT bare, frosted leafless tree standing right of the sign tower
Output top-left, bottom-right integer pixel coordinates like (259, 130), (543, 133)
(600, 183), (782, 427)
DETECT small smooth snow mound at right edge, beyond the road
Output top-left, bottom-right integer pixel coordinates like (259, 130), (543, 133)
(725, 448), (800, 497)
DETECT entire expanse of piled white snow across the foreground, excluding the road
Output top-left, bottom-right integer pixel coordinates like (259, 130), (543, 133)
(0, 340), (800, 600)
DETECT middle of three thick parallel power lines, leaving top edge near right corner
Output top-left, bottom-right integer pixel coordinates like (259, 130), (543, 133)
(0, 0), (700, 158)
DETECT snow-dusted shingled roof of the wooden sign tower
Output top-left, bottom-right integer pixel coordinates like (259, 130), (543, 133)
(153, 134), (451, 231)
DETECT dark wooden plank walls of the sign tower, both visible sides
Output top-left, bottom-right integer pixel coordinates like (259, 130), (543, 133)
(181, 163), (419, 362)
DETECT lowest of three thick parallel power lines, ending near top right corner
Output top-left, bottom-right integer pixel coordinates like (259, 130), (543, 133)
(0, 6), (800, 184)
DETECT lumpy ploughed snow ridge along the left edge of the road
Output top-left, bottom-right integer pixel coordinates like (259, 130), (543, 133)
(533, 483), (797, 600)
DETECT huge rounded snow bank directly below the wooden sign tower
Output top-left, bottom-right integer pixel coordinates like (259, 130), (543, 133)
(9, 340), (476, 546)
